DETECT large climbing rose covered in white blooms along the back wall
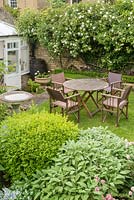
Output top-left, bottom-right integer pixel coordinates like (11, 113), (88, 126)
(37, 0), (134, 71)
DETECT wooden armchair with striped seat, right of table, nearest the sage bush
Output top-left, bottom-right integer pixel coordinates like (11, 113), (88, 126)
(102, 86), (132, 126)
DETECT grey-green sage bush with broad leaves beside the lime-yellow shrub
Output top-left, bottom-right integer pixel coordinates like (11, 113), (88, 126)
(12, 127), (134, 200)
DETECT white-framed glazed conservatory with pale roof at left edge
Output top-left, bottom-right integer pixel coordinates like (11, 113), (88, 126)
(0, 21), (29, 89)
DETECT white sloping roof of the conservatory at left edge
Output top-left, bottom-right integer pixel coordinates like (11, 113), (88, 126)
(0, 21), (18, 37)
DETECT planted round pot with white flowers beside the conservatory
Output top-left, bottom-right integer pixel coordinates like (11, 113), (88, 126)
(35, 71), (50, 84)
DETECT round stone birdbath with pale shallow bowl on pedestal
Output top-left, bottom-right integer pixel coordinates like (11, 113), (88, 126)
(0, 91), (33, 112)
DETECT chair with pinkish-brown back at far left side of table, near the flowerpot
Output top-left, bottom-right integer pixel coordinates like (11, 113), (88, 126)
(51, 72), (73, 94)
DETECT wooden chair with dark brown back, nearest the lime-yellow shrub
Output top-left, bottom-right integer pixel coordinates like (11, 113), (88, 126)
(46, 87), (80, 123)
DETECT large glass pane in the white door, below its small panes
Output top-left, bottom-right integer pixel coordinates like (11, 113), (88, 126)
(8, 50), (19, 73)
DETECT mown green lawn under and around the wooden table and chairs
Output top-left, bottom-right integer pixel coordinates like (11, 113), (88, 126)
(39, 74), (134, 141)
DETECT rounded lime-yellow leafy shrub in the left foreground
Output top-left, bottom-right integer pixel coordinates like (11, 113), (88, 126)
(0, 112), (78, 180)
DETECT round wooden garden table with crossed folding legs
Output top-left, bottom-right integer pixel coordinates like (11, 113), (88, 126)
(63, 78), (108, 117)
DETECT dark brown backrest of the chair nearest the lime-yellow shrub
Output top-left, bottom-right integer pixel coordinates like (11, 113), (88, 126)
(46, 87), (66, 102)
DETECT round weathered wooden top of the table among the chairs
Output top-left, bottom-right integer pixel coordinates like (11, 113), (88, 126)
(63, 78), (108, 91)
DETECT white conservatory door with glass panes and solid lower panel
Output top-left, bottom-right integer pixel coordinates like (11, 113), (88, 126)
(4, 40), (21, 89)
